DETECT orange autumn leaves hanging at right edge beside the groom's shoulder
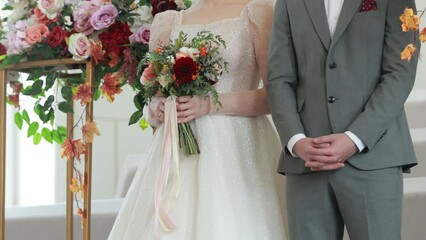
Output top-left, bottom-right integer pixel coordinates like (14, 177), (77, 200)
(399, 8), (426, 61)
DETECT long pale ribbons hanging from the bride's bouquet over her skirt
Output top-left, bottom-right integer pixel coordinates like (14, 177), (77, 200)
(154, 96), (180, 239)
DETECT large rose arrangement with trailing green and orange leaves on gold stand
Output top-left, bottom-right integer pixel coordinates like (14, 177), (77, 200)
(0, 0), (191, 221)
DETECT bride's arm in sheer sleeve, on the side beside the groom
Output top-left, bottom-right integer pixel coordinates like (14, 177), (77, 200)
(211, 0), (274, 116)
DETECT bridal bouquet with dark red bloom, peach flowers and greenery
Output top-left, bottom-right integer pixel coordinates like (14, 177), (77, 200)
(129, 31), (228, 155)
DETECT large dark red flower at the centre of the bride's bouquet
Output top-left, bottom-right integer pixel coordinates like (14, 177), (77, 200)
(173, 57), (198, 84)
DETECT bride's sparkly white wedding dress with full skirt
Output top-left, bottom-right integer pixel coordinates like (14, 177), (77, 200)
(108, 0), (286, 240)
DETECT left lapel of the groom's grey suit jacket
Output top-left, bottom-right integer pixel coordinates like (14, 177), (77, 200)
(304, 0), (332, 50)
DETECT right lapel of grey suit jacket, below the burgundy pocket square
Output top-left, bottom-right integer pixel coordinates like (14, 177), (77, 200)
(330, 0), (362, 48)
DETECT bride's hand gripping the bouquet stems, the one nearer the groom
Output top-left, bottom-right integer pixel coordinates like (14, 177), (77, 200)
(176, 95), (211, 123)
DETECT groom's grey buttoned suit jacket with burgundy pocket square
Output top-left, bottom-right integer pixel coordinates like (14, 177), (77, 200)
(267, 0), (420, 173)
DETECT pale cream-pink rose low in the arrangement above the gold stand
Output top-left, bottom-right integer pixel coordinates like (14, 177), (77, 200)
(68, 33), (91, 61)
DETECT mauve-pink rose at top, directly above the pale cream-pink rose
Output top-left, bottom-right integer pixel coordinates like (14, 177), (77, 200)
(72, 1), (99, 35)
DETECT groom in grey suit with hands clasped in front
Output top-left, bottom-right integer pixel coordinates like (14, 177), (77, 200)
(267, 0), (419, 240)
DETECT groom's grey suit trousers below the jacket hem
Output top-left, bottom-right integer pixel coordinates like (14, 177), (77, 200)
(286, 163), (403, 240)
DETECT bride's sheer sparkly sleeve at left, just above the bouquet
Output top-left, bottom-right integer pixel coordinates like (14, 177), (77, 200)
(149, 10), (177, 51)
